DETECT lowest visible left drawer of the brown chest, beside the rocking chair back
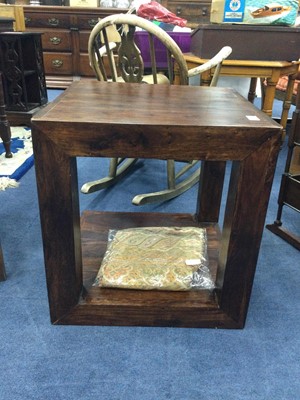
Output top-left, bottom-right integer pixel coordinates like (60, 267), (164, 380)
(43, 52), (73, 75)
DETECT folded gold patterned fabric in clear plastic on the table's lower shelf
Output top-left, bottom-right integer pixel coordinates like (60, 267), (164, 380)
(95, 227), (214, 290)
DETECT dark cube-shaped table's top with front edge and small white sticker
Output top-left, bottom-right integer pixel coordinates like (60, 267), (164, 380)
(32, 79), (281, 159)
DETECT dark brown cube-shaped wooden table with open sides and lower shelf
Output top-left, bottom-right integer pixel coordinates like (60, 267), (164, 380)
(32, 80), (281, 328)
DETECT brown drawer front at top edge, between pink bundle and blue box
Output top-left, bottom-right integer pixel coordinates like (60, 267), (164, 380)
(168, 1), (211, 24)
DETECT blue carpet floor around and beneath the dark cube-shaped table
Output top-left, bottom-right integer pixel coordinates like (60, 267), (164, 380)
(0, 89), (300, 400)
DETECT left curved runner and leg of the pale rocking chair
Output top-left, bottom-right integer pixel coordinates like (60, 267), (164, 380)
(81, 158), (137, 194)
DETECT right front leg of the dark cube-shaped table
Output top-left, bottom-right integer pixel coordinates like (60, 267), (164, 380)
(217, 136), (281, 325)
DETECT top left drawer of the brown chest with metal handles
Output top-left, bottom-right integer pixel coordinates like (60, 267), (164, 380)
(25, 12), (70, 29)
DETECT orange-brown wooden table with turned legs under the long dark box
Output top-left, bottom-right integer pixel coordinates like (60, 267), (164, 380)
(175, 53), (300, 134)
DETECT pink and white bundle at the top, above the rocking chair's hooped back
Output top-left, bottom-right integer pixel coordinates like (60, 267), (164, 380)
(136, 1), (187, 27)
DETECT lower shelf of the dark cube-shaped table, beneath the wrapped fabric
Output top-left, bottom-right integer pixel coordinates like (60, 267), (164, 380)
(54, 211), (240, 328)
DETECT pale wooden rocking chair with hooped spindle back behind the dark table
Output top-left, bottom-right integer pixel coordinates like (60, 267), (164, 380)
(81, 14), (232, 205)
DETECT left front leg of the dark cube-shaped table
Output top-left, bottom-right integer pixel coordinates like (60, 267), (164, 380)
(32, 127), (82, 323)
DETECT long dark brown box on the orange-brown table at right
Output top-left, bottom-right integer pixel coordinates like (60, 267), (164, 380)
(191, 24), (300, 61)
